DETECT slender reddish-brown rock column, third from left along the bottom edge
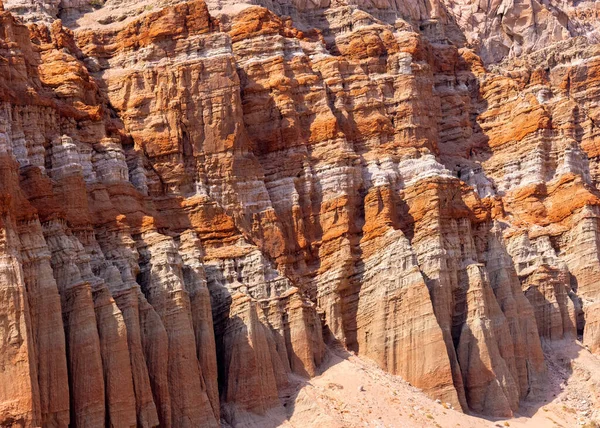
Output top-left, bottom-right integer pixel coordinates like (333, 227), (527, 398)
(21, 155), (105, 427)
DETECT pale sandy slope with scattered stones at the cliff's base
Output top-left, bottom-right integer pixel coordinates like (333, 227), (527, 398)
(229, 342), (600, 428)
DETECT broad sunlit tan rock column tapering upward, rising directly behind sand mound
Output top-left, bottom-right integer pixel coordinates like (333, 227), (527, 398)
(358, 226), (460, 408)
